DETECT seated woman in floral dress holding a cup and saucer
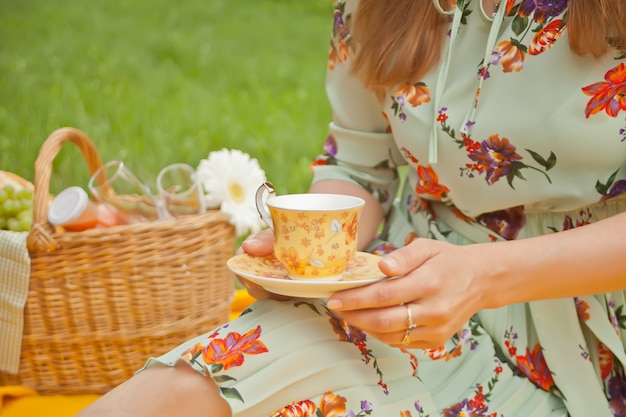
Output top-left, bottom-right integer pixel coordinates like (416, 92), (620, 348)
(80, 0), (626, 417)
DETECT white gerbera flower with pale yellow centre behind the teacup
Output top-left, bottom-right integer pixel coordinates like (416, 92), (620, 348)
(196, 149), (266, 237)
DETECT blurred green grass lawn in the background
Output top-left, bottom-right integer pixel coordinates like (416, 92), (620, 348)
(0, 0), (332, 193)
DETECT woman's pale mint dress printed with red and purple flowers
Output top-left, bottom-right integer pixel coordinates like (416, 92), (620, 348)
(141, 0), (626, 417)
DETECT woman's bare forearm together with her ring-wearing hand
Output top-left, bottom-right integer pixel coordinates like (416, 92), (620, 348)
(328, 208), (626, 348)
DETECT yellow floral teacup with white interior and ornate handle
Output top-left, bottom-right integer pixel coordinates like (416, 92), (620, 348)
(256, 182), (365, 281)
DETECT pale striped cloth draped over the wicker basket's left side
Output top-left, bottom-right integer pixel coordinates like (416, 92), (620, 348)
(0, 230), (30, 374)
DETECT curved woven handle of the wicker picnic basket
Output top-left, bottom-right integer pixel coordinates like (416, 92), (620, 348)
(26, 127), (102, 251)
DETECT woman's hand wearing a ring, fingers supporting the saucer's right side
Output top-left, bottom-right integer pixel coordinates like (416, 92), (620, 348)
(328, 239), (491, 348)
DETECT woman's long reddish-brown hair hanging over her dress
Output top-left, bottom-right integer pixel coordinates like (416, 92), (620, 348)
(351, 0), (626, 91)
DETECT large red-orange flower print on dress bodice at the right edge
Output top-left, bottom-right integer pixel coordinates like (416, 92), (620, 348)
(582, 62), (626, 117)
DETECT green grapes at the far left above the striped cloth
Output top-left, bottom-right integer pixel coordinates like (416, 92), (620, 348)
(0, 185), (33, 232)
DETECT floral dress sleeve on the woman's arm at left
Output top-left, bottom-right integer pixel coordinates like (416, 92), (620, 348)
(312, 1), (404, 211)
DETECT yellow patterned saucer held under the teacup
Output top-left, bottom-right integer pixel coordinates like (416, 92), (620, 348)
(226, 252), (387, 298)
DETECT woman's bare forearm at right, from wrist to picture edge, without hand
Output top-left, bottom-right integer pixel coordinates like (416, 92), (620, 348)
(473, 213), (626, 307)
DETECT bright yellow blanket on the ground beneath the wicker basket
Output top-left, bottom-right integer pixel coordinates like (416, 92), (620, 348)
(0, 290), (254, 417)
